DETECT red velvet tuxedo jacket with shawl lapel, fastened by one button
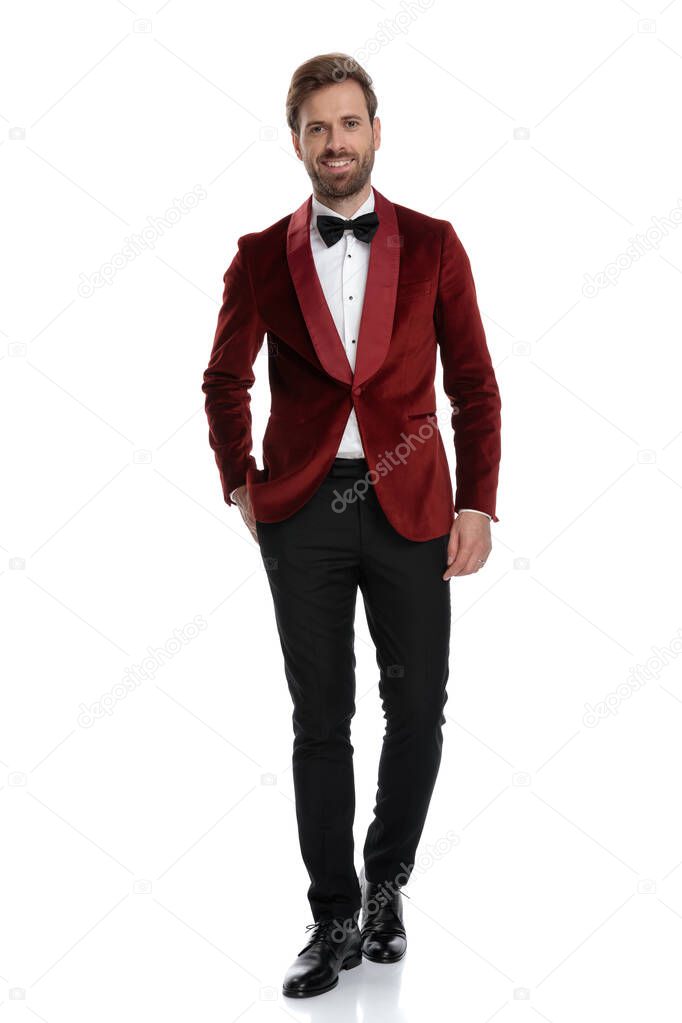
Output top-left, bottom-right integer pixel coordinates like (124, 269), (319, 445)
(201, 188), (501, 540)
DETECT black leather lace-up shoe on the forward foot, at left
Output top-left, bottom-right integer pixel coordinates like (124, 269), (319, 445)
(282, 918), (362, 998)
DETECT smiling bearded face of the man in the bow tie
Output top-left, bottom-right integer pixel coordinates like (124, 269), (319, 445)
(291, 79), (381, 198)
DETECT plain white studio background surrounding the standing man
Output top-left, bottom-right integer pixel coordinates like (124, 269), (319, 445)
(0, 0), (682, 1023)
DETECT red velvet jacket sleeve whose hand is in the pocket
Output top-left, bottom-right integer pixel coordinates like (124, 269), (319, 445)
(201, 237), (266, 504)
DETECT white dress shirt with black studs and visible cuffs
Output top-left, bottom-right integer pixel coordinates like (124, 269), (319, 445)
(230, 188), (491, 519)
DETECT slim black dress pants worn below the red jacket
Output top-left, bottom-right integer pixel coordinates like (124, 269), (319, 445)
(257, 458), (450, 921)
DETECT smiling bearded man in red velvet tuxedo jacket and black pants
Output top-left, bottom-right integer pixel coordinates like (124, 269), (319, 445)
(202, 53), (500, 997)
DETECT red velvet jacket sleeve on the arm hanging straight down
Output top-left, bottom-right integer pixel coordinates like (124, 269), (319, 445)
(434, 215), (501, 522)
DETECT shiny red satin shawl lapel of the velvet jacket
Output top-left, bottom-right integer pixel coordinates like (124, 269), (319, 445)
(286, 188), (401, 387)
